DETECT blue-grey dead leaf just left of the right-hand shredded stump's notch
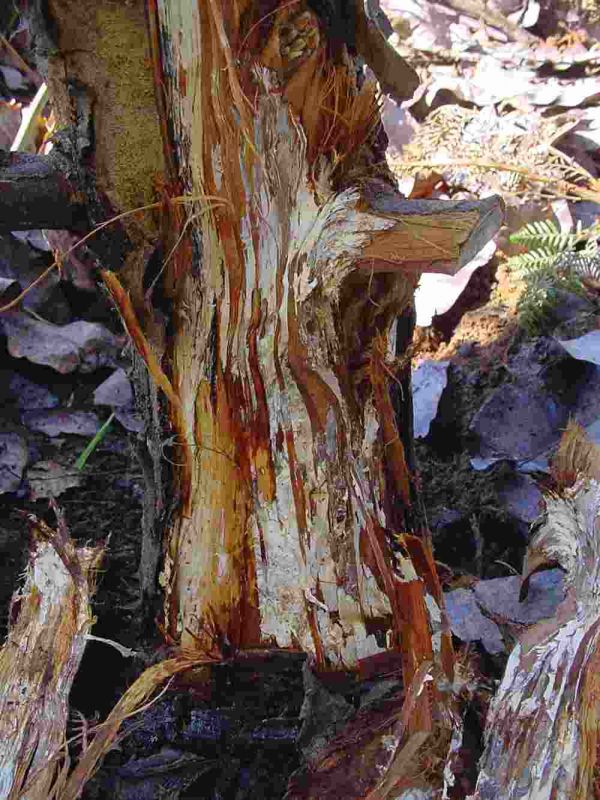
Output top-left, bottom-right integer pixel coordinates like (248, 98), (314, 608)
(473, 569), (565, 625)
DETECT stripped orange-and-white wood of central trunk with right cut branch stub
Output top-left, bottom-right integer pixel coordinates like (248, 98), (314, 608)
(150, 0), (501, 681)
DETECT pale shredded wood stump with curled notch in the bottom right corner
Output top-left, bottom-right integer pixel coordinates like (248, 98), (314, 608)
(474, 424), (600, 800)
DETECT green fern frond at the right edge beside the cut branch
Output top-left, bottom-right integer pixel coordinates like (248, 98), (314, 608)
(507, 220), (600, 336)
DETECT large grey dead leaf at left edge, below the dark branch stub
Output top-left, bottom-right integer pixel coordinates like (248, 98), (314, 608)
(0, 312), (122, 374)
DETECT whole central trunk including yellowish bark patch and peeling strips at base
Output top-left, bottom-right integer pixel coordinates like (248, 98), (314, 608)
(2, 0), (502, 800)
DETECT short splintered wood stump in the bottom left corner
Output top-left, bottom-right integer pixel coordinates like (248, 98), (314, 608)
(0, 516), (102, 800)
